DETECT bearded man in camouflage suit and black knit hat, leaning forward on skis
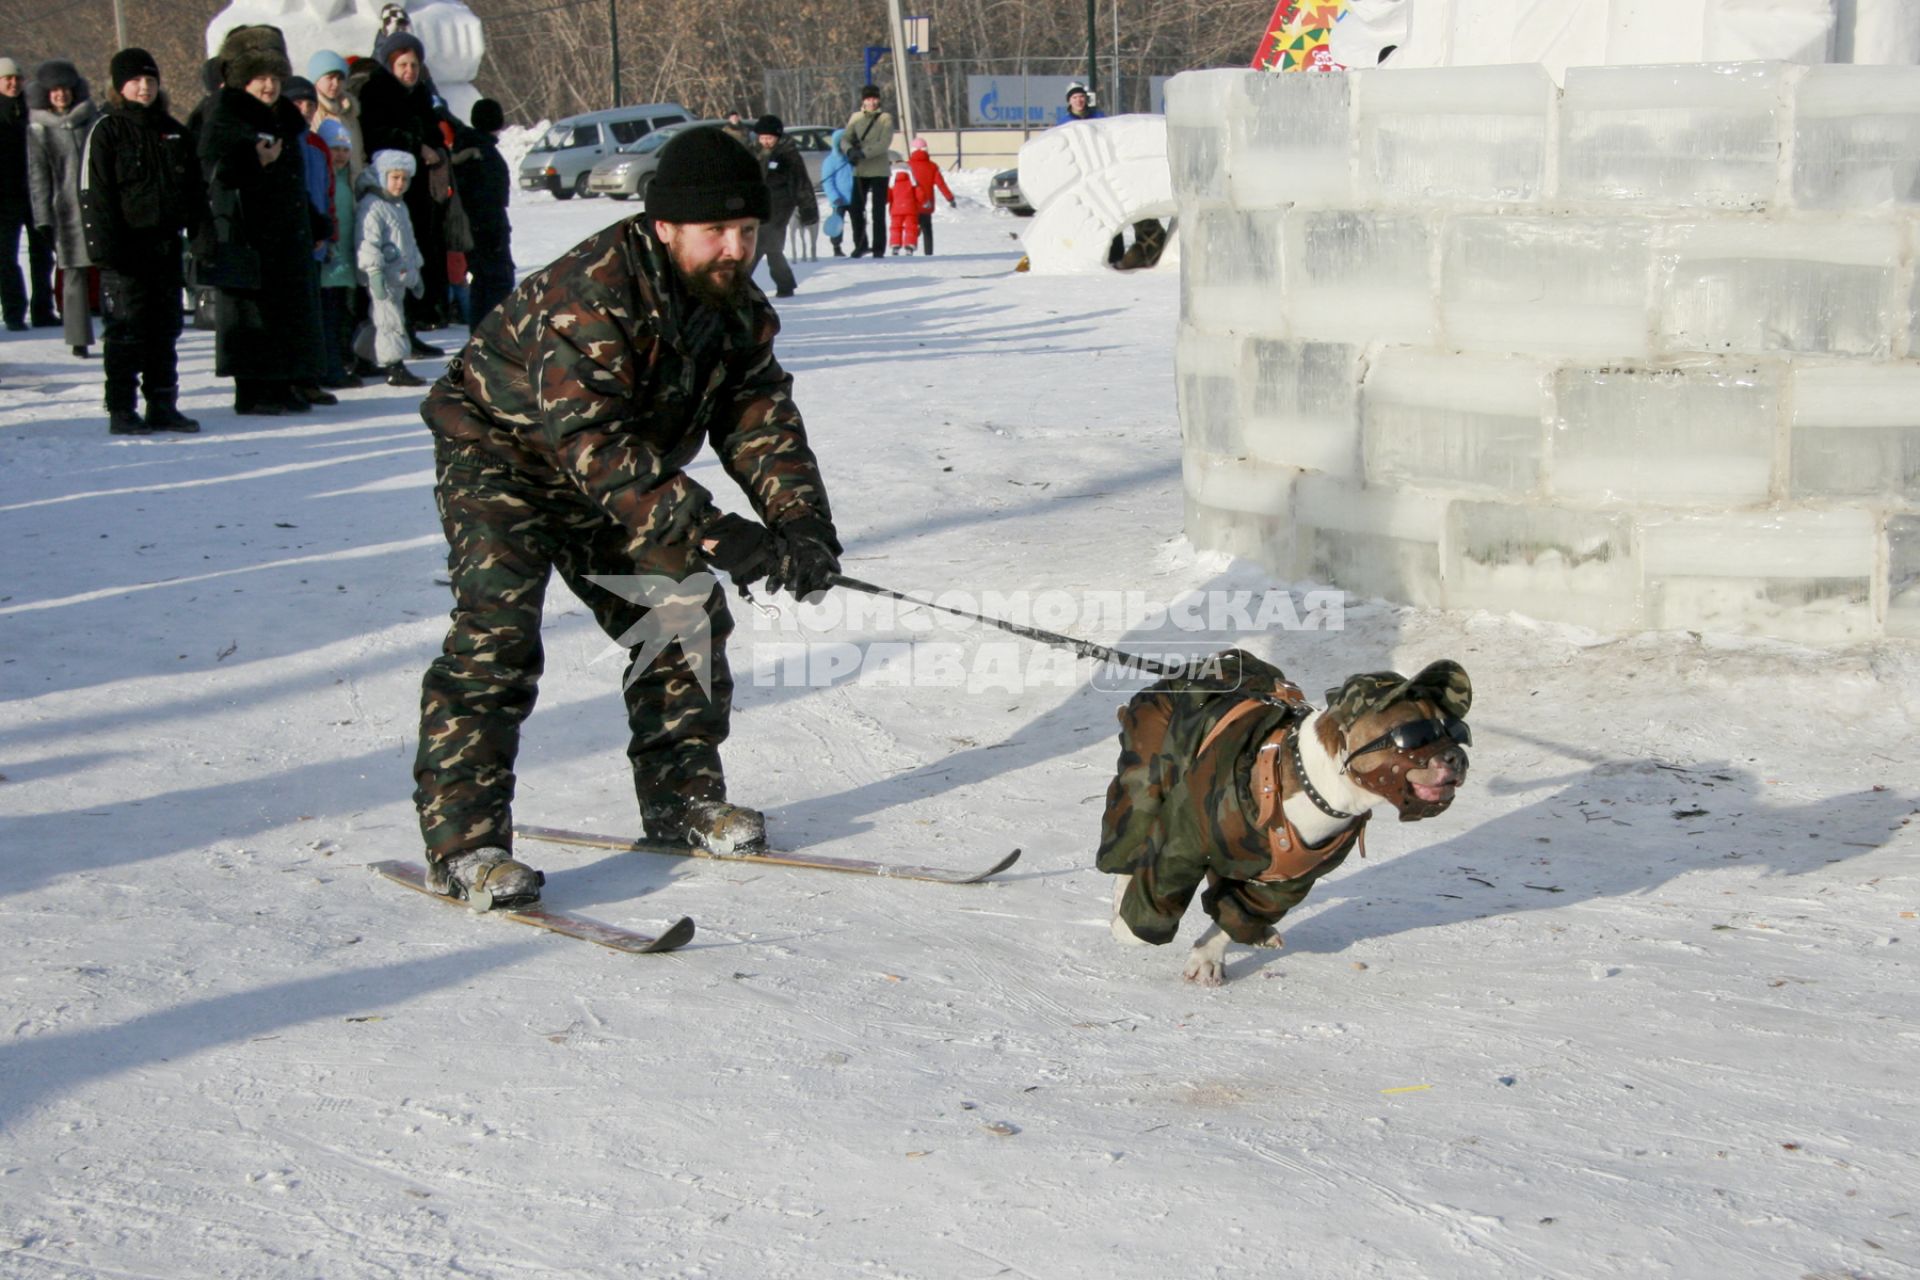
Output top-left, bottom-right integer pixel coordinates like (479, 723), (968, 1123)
(413, 127), (839, 904)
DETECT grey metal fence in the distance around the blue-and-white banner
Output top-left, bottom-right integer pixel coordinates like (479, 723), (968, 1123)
(762, 54), (1185, 130)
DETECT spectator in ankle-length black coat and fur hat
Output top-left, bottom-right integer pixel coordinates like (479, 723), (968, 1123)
(200, 27), (328, 415)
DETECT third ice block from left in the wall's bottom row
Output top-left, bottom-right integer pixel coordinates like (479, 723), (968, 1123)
(1446, 501), (1640, 631)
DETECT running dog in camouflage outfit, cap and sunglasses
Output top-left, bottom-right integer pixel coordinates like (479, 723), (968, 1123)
(1094, 651), (1473, 986)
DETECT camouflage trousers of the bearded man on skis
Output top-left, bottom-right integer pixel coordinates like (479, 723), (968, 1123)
(413, 441), (733, 860)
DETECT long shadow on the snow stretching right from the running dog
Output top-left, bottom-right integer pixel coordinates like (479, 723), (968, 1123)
(1235, 760), (1916, 973)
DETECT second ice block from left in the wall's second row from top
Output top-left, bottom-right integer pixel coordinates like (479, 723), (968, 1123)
(1284, 209), (1438, 345)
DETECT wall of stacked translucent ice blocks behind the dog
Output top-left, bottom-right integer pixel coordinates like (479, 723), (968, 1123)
(1167, 63), (1920, 645)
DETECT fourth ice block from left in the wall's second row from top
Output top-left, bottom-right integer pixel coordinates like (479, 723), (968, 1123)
(1653, 219), (1905, 355)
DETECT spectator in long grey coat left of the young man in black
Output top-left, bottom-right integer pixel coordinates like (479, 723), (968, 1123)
(27, 59), (100, 355)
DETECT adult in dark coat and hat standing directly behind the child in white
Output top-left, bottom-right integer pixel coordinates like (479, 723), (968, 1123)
(353, 31), (449, 347)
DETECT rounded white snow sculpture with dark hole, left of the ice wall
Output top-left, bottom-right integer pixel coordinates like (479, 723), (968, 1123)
(1020, 115), (1173, 274)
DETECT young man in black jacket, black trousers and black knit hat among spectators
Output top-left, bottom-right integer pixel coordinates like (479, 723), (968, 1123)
(81, 48), (202, 436)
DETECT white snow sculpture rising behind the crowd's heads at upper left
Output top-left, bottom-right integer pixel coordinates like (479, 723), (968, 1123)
(207, 0), (486, 119)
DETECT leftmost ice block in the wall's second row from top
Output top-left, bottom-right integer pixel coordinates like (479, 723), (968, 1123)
(1181, 209), (1286, 338)
